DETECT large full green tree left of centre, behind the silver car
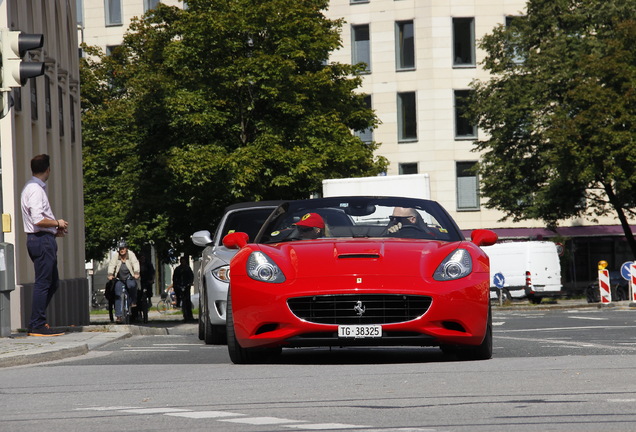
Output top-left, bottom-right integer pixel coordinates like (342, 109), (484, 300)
(83, 0), (387, 260)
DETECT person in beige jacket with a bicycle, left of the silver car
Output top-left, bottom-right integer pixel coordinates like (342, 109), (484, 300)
(108, 240), (139, 324)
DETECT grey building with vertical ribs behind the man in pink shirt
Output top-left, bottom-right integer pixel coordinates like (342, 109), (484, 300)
(0, 0), (85, 329)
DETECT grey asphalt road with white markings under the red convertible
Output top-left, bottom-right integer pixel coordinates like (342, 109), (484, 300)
(0, 309), (636, 432)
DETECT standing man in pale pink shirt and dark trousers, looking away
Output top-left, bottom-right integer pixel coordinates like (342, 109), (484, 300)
(21, 154), (68, 336)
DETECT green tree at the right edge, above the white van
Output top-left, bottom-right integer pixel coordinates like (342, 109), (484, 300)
(469, 0), (636, 257)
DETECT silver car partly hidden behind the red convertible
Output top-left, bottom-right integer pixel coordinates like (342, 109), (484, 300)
(192, 201), (280, 344)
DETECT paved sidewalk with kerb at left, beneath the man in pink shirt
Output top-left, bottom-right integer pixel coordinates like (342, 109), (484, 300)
(0, 311), (198, 368)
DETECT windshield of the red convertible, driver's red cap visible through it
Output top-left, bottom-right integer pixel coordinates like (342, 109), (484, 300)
(255, 197), (464, 243)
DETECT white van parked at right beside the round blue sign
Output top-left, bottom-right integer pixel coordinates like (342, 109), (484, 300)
(482, 241), (563, 304)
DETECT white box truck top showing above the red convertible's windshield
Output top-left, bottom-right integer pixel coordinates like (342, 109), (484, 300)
(322, 174), (431, 199)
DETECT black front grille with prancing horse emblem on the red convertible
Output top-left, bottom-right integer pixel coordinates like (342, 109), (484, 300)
(287, 294), (431, 325)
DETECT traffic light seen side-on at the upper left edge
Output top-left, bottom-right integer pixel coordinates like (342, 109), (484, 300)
(0, 29), (44, 91)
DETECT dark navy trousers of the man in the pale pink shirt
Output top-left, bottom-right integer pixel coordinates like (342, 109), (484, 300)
(27, 232), (60, 329)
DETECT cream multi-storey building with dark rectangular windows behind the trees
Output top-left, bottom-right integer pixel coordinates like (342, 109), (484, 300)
(77, 0), (632, 290)
